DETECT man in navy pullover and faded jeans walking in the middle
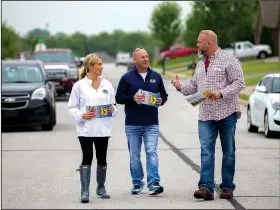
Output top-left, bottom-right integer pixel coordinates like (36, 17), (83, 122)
(116, 48), (168, 195)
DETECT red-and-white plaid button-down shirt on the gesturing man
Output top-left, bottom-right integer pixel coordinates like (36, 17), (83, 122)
(180, 48), (245, 121)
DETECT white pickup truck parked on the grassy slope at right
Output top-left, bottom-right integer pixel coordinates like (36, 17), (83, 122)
(224, 41), (272, 59)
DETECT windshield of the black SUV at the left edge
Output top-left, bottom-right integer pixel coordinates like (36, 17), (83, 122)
(2, 64), (43, 83)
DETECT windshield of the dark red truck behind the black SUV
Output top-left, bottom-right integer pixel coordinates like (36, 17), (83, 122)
(32, 51), (74, 63)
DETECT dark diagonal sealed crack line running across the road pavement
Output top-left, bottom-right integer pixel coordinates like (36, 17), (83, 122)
(159, 132), (246, 209)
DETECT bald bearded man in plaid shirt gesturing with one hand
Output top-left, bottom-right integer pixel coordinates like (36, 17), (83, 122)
(171, 30), (245, 200)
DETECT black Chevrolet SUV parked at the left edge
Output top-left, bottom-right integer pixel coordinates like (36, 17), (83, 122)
(1, 60), (56, 131)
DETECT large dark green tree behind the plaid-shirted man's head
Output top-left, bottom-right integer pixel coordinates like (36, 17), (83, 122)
(184, 0), (258, 47)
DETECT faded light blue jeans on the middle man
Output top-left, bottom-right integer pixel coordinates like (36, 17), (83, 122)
(125, 125), (160, 187)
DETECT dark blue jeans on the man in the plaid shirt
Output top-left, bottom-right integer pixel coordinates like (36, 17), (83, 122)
(198, 113), (237, 194)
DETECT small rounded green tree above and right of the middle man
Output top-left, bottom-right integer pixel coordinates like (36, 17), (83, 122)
(149, 2), (182, 48)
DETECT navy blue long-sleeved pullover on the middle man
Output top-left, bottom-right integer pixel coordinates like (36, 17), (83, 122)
(116, 67), (168, 125)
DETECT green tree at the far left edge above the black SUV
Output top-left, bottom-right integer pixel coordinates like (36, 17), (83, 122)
(1, 22), (20, 60)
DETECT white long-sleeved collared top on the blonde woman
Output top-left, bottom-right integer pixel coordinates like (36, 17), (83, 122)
(67, 76), (118, 137)
